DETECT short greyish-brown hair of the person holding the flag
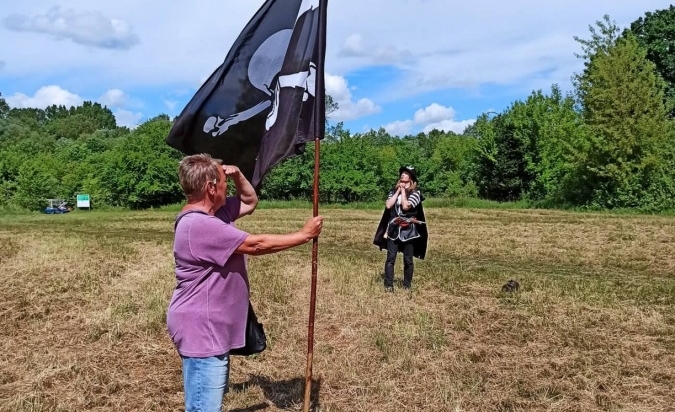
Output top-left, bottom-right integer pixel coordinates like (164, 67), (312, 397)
(178, 153), (223, 200)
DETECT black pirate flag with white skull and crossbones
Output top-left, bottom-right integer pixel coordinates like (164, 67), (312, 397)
(166, 0), (328, 188)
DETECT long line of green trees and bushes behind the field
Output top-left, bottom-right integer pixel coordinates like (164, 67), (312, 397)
(0, 6), (675, 211)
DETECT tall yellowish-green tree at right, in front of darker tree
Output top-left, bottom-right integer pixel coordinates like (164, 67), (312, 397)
(575, 19), (669, 208)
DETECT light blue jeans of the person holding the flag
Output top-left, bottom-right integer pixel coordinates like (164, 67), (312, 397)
(181, 353), (230, 412)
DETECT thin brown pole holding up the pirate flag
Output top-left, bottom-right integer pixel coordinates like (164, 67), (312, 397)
(304, 0), (328, 412)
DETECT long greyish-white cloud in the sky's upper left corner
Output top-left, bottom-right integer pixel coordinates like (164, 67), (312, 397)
(4, 6), (139, 49)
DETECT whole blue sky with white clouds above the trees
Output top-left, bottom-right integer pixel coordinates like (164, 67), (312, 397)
(0, 0), (671, 135)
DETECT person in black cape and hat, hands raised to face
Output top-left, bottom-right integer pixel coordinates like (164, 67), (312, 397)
(373, 166), (429, 292)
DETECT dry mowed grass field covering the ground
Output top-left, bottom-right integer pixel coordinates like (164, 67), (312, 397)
(0, 208), (675, 412)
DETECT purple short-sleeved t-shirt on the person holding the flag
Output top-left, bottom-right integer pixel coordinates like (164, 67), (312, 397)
(166, 197), (249, 358)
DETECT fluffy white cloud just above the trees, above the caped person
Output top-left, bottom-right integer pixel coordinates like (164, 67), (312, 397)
(384, 103), (476, 136)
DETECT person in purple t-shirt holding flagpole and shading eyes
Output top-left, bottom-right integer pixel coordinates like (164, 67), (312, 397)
(167, 154), (323, 412)
